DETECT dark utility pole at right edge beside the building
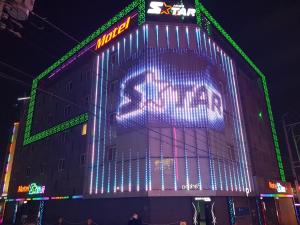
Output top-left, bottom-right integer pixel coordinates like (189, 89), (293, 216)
(282, 114), (300, 201)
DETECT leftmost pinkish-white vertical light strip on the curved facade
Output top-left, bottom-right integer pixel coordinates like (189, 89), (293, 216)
(90, 55), (99, 194)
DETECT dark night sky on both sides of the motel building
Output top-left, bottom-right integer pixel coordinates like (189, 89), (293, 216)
(0, 0), (300, 179)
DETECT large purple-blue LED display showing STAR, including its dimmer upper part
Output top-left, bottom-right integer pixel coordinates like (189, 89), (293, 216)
(117, 50), (224, 129)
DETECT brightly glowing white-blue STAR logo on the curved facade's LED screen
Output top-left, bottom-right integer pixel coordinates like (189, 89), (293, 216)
(117, 69), (224, 127)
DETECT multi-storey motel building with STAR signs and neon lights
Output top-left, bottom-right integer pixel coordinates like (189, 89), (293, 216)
(1, 0), (297, 225)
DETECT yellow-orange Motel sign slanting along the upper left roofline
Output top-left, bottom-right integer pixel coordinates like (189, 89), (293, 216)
(95, 16), (132, 50)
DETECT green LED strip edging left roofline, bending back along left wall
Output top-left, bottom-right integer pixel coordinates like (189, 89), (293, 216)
(23, 0), (145, 145)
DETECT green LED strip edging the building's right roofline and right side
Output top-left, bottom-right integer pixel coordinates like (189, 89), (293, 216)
(195, 0), (286, 182)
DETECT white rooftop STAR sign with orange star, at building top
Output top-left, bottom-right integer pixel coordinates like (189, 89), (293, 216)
(147, 1), (196, 17)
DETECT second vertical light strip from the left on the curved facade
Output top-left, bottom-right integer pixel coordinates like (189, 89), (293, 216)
(95, 52), (105, 194)
